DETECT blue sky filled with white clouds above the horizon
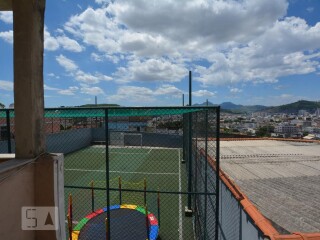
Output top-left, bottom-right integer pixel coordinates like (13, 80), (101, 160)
(0, 0), (320, 107)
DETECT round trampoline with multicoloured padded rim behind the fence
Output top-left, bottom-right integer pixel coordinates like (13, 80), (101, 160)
(72, 204), (159, 240)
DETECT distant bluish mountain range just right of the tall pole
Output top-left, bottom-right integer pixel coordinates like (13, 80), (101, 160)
(194, 102), (267, 113)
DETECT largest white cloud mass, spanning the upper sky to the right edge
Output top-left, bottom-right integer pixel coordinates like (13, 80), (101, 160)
(64, 0), (320, 86)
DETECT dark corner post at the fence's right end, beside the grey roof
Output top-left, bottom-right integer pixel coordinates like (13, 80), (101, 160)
(215, 106), (220, 240)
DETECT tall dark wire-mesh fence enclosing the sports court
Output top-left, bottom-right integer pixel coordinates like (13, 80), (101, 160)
(0, 107), (219, 240)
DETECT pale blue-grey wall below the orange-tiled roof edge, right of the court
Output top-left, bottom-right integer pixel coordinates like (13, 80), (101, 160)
(198, 155), (264, 240)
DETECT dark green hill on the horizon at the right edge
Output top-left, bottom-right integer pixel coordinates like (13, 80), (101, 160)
(264, 100), (320, 114)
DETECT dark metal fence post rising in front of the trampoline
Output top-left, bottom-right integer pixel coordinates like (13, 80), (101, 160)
(104, 108), (111, 239)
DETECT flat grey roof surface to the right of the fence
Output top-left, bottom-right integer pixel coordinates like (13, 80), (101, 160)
(220, 140), (320, 234)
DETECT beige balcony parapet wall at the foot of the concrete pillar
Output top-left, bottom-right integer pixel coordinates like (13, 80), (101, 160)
(0, 154), (66, 240)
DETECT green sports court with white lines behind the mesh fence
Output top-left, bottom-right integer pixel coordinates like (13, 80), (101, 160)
(64, 145), (194, 239)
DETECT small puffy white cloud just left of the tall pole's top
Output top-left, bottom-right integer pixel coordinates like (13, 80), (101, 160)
(114, 58), (188, 82)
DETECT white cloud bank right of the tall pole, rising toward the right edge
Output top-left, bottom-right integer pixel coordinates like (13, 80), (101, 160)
(196, 17), (320, 85)
